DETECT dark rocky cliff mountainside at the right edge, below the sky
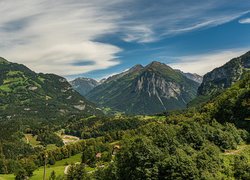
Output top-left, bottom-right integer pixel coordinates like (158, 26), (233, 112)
(198, 51), (250, 96)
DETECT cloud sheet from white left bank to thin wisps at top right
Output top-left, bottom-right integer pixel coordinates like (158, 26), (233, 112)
(0, 0), (250, 75)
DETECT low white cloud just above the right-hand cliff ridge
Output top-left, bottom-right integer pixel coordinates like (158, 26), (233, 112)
(169, 48), (249, 75)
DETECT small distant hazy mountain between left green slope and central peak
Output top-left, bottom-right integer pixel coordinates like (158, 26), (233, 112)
(70, 77), (99, 96)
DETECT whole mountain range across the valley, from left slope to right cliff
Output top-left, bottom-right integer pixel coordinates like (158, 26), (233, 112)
(0, 52), (250, 116)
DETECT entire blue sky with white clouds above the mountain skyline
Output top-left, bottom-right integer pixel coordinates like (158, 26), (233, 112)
(0, 0), (250, 79)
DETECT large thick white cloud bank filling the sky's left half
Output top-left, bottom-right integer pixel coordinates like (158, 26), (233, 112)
(0, 0), (121, 75)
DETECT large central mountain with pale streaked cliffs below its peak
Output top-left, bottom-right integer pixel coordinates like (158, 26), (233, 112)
(86, 62), (199, 114)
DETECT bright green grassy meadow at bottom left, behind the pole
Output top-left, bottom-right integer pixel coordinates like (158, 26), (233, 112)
(0, 153), (81, 180)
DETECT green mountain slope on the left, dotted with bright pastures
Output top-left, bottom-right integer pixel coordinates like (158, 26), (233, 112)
(0, 58), (101, 120)
